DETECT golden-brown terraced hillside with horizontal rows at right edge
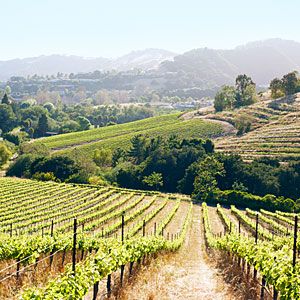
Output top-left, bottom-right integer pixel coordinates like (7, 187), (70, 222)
(203, 94), (300, 161)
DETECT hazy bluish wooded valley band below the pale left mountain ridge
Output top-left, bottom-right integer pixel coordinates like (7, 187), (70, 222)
(8, 70), (204, 105)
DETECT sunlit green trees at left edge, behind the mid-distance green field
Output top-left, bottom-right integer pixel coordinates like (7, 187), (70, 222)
(0, 88), (154, 145)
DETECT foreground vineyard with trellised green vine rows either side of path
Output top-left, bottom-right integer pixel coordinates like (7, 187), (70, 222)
(0, 177), (300, 299)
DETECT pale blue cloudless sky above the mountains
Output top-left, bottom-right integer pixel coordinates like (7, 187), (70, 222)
(0, 0), (300, 60)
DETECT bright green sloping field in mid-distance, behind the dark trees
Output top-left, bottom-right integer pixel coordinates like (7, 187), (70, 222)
(32, 114), (224, 153)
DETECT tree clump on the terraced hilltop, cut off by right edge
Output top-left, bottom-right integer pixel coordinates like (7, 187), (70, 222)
(270, 71), (300, 99)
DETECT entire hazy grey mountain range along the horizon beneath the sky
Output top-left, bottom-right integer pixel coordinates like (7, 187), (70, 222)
(0, 39), (300, 88)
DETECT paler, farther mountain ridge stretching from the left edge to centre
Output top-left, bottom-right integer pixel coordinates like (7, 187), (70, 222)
(0, 49), (176, 80)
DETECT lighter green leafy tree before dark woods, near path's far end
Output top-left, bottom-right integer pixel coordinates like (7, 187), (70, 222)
(192, 156), (224, 201)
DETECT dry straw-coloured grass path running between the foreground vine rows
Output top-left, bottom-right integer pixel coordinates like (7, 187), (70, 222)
(119, 206), (235, 300)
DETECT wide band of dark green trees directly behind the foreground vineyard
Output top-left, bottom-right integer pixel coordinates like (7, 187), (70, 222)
(7, 135), (300, 211)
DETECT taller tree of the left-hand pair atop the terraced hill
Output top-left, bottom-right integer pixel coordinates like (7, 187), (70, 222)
(235, 74), (256, 107)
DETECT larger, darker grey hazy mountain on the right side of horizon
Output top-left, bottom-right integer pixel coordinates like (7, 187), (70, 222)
(160, 39), (300, 88)
